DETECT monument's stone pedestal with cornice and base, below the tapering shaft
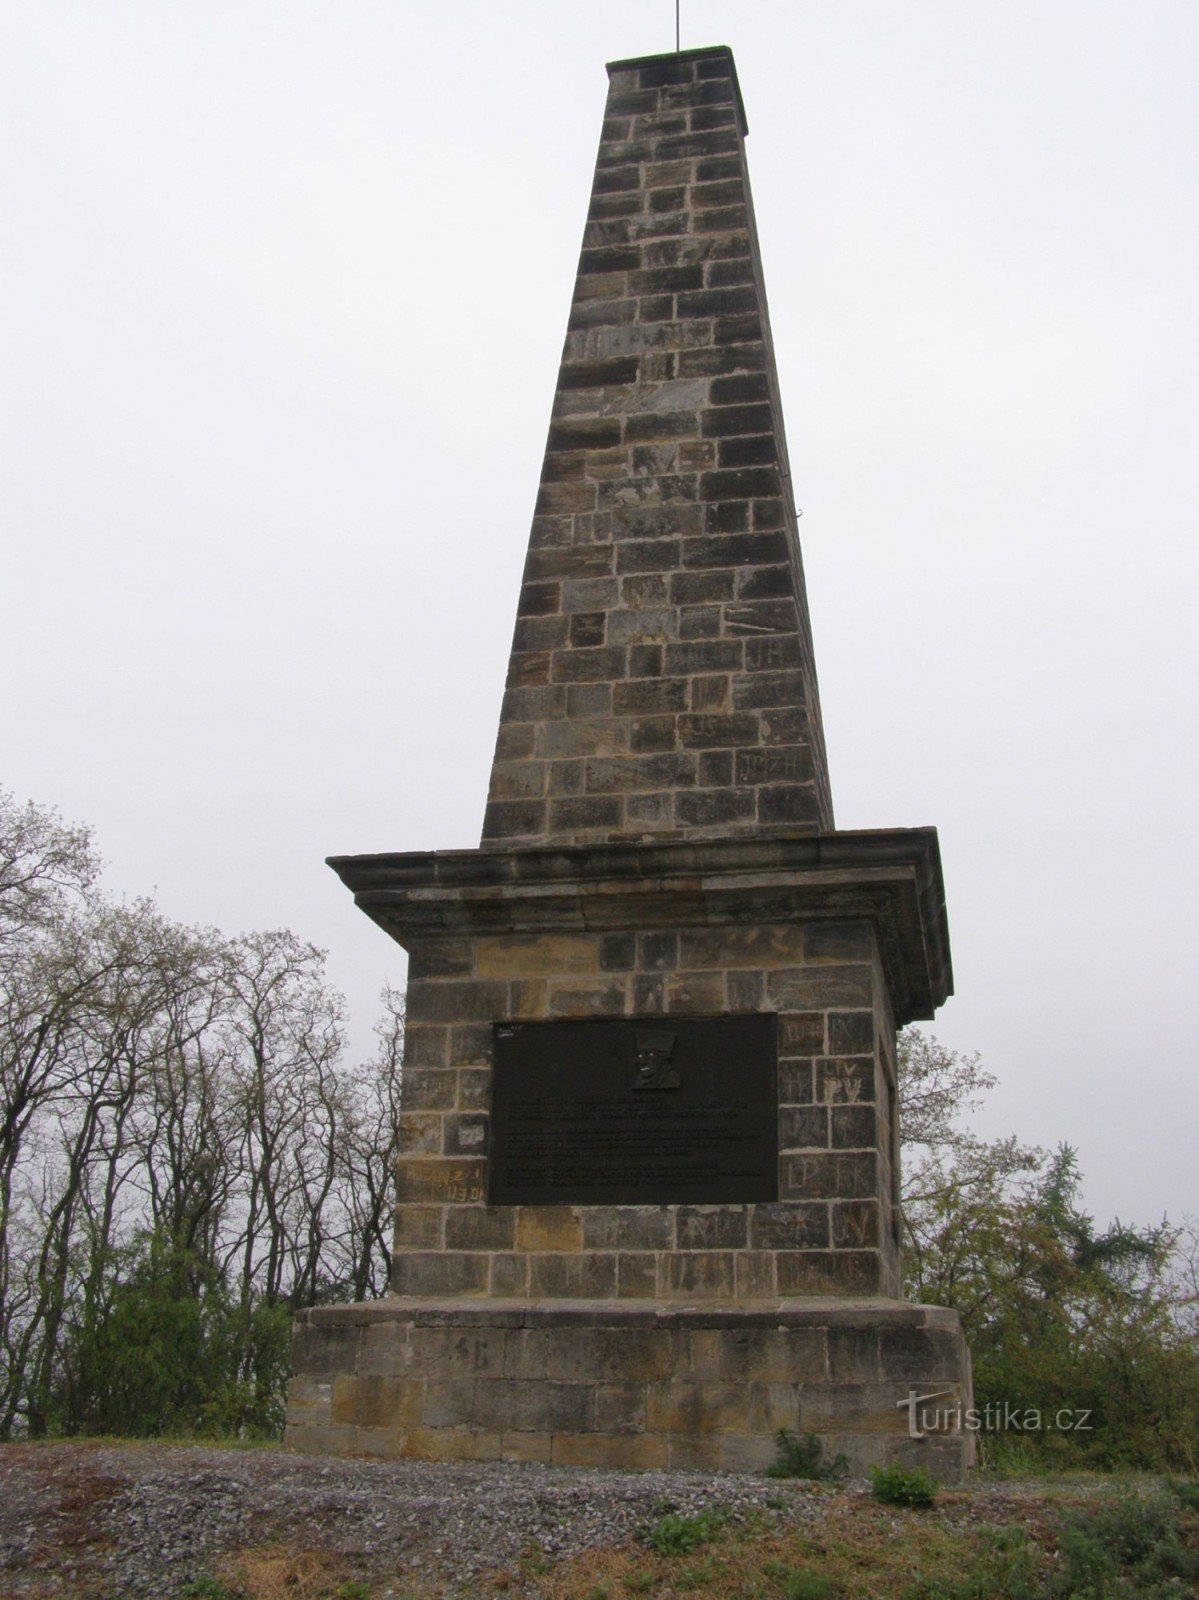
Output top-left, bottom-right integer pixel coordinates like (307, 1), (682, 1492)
(288, 829), (973, 1477)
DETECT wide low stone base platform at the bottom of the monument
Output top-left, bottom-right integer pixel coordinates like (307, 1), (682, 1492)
(287, 1299), (975, 1482)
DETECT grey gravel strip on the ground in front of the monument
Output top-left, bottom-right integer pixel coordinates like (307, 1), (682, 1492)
(0, 1443), (824, 1600)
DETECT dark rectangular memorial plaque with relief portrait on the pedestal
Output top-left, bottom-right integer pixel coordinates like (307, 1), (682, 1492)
(488, 1013), (778, 1205)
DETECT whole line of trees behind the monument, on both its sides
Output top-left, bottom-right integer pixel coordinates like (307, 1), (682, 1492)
(0, 780), (1199, 1474)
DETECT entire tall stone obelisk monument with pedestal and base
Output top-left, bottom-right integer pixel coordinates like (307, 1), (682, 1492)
(288, 48), (972, 1475)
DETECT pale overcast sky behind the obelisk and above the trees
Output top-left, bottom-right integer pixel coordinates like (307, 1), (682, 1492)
(0, 0), (1199, 1222)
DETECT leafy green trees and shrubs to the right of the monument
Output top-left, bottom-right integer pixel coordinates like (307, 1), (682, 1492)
(900, 1029), (1199, 1477)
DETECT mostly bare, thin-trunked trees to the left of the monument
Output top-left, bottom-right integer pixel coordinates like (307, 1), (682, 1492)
(0, 794), (403, 1438)
